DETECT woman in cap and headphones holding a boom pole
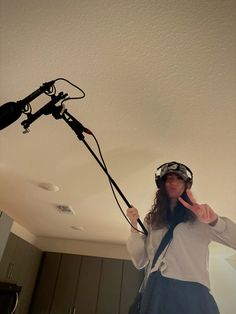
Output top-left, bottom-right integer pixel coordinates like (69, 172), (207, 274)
(127, 162), (236, 314)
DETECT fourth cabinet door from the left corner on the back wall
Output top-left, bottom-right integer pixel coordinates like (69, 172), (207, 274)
(95, 258), (123, 314)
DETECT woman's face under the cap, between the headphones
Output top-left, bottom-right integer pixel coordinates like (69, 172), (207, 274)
(165, 173), (185, 199)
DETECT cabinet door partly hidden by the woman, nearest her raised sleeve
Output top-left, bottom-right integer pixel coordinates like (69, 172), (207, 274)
(120, 261), (144, 314)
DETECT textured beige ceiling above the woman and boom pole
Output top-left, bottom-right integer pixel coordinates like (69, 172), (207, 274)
(0, 0), (236, 243)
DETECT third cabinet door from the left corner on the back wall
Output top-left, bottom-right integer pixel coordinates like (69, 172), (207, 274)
(74, 256), (102, 314)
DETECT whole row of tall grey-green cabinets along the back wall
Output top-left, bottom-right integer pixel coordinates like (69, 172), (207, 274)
(30, 252), (143, 314)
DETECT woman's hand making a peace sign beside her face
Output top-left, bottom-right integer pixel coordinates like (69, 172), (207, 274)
(178, 189), (218, 224)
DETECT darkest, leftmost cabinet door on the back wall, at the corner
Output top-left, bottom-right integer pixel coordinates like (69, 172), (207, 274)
(29, 252), (61, 314)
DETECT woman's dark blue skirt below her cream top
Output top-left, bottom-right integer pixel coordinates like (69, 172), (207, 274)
(140, 271), (220, 314)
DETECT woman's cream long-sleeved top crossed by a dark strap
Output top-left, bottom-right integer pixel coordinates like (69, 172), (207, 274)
(127, 217), (236, 289)
